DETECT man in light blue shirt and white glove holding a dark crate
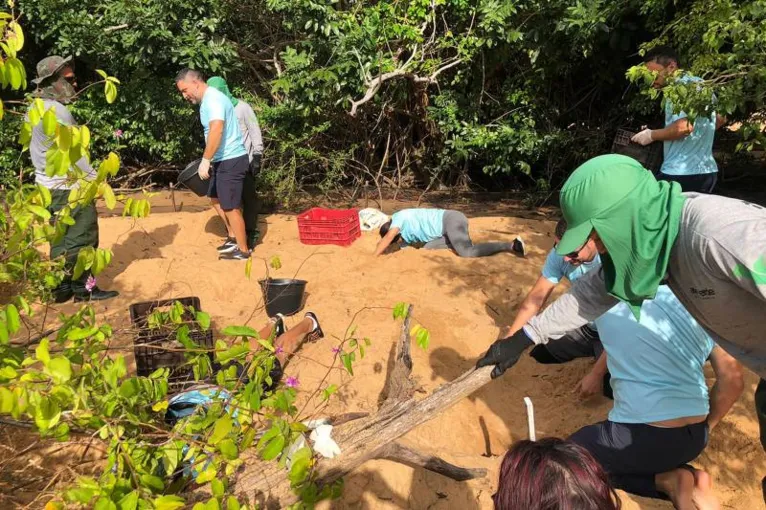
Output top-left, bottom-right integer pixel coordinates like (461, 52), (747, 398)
(633, 47), (726, 193)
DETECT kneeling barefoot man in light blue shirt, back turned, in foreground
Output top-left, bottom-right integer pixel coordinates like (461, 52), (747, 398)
(568, 285), (744, 508)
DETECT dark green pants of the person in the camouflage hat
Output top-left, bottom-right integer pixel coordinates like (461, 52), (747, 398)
(48, 190), (98, 290)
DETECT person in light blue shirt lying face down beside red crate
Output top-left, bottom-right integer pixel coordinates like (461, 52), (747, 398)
(375, 209), (526, 257)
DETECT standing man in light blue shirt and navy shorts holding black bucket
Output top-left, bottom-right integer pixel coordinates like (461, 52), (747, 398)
(176, 69), (250, 260)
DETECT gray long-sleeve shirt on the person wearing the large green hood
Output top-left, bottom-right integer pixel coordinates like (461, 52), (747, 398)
(524, 193), (766, 378)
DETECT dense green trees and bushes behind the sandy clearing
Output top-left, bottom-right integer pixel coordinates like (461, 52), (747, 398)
(6, 0), (766, 196)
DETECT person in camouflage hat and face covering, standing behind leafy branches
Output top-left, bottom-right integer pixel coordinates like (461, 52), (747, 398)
(27, 56), (119, 303)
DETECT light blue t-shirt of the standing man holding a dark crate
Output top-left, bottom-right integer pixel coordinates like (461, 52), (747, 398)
(660, 76), (718, 175)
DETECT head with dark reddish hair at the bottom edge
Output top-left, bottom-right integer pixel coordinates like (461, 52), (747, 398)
(492, 437), (621, 510)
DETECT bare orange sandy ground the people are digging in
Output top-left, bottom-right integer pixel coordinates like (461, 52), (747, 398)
(0, 192), (766, 510)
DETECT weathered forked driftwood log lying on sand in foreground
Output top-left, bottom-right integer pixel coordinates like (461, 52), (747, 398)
(232, 305), (492, 508)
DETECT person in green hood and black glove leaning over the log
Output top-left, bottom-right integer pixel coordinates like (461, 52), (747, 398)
(477, 154), (766, 500)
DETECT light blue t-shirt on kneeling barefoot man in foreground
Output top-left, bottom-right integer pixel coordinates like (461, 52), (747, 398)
(596, 285), (715, 423)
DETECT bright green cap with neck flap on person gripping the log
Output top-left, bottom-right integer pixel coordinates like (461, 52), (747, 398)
(556, 154), (686, 319)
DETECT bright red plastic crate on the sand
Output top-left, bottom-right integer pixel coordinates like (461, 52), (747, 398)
(298, 207), (362, 246)
